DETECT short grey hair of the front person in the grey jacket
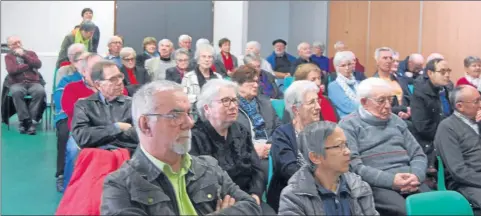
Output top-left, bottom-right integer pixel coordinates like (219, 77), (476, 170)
(298, 121), (337, 160)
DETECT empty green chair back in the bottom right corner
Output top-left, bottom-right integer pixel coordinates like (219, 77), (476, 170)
(406, 191), (474, 215)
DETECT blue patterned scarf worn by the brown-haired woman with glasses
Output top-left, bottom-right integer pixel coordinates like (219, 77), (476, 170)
(239, 96), (267, 139)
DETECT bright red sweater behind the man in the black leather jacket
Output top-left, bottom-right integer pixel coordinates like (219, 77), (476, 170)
(62, 80), (128, 130)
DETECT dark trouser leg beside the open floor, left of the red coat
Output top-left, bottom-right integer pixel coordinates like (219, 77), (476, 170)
(55, 119), (69, 177)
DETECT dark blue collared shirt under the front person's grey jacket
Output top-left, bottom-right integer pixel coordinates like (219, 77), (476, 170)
(316, 175), (351, 215)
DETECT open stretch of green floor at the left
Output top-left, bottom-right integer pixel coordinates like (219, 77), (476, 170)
(0, 117), (62, 215)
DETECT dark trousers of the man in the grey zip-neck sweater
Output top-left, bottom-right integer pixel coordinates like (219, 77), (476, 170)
(371, 184), (431, 216)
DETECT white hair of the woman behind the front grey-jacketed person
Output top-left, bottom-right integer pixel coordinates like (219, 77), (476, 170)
(284, 80), (319, 119)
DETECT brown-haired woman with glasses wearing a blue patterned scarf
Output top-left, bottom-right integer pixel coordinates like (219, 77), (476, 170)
(232, 65), (281, 179)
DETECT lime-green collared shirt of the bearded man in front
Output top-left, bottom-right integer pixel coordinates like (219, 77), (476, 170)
(140, 145), (197, 215)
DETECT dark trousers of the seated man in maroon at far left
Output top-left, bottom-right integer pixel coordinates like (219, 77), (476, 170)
(10, 83), (45, 122)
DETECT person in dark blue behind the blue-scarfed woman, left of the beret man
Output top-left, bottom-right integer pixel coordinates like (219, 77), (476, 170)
(244, 53), (283, 99)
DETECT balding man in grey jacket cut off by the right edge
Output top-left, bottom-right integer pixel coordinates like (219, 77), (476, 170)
(434, 85), (481, 215)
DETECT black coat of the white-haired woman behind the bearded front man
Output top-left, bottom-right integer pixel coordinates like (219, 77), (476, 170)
(190, 120), (265, 198)
